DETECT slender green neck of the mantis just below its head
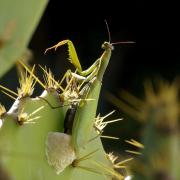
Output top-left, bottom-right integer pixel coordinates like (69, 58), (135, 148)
(97, 48), (112, 81)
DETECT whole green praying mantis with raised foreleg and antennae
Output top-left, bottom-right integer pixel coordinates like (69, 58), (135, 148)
(45, 23), (134, 154)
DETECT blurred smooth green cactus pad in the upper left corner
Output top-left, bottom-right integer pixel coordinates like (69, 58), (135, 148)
(0, 0), (48, 77)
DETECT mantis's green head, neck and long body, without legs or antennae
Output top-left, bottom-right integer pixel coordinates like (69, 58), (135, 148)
(72, 42), (112, 152)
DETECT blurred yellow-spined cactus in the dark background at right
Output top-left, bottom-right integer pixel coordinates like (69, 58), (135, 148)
(108, 80), (180, 180)
